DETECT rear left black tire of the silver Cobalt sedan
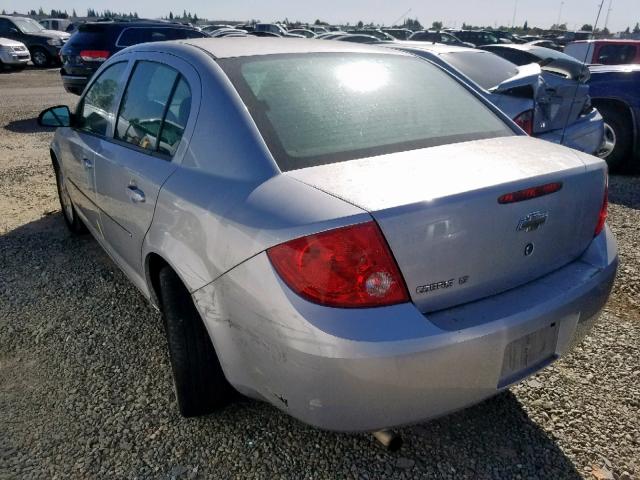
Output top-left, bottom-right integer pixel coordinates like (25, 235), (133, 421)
(159, 266), (236, 417)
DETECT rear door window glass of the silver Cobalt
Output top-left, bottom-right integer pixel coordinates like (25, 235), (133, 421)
(115, 61), (191, 156)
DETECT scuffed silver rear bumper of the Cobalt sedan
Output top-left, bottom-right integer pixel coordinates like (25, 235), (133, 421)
(194, 228), (618, 431)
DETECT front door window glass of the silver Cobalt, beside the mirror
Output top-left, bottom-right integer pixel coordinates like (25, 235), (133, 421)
(78, 62), (127, 136)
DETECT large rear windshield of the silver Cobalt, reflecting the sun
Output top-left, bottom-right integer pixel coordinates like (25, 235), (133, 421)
(219, 53), (513, 171)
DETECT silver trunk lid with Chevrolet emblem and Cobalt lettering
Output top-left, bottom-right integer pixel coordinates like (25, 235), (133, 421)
(286, 136), (606, 312)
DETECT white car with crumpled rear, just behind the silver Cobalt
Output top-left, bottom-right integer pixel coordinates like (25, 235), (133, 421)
(391, 42), (604, 154)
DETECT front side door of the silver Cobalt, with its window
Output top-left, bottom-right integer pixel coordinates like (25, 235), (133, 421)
(62, 61), (128, 232)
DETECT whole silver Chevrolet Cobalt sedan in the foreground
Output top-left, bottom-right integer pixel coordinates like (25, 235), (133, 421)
(40, 37), (617, 431)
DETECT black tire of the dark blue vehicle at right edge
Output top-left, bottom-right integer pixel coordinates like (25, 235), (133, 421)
(598, 104), (633, 173)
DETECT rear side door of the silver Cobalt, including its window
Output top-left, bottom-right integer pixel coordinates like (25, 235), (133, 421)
(96, 53), (200, 281)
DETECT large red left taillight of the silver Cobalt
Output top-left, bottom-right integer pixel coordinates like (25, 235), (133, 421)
(267, 222), (409, 308)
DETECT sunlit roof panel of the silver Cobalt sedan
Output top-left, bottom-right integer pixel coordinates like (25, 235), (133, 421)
(165, 36), (401, 58)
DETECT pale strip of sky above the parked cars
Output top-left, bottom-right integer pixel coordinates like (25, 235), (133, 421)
(0, 0), (640, 31)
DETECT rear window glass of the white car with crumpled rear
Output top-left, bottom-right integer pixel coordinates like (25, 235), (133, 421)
(441, 50), (518, 89)
